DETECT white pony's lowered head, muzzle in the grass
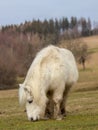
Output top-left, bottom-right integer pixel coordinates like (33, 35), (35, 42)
(19, 84), (45, 121)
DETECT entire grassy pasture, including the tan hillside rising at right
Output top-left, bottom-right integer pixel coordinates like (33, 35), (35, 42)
(0, 36), (98, 130)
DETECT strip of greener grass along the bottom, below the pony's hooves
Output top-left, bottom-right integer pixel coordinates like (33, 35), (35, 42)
(0, 114), (98, 130)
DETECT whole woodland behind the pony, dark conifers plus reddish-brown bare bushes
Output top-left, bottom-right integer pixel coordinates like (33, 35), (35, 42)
(0, 17), (98, 89)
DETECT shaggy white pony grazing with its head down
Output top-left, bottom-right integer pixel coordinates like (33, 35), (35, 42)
(19, 45), (78, 121)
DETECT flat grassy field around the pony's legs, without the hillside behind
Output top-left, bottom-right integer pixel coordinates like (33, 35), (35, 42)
(0, 86), (98, 130)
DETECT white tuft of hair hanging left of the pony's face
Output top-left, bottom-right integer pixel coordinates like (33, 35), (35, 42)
(19, 84), (26, 105)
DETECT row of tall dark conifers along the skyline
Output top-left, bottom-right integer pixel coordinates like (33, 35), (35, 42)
(1, 17), (96, 37)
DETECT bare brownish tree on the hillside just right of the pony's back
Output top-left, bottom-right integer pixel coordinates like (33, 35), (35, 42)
(61, 38), (88, 69)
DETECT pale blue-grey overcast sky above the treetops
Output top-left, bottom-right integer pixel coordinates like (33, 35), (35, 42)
(0, 0), (98, 25)
